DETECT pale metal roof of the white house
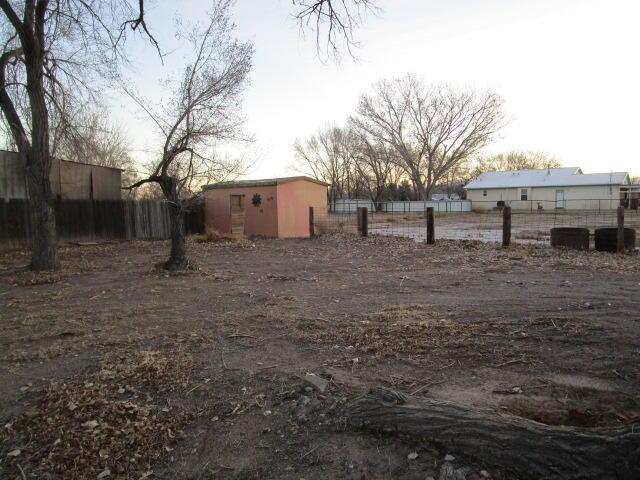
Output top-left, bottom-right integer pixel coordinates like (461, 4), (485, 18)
(465, 167), (629, 190)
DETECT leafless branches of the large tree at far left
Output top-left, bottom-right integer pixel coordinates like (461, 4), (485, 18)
(0, 0), (155, 146)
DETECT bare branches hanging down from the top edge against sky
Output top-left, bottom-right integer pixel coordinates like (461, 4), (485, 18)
(293, 0), (378, 58)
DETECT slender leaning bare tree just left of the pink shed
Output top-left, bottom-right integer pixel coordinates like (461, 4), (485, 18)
(128, 0), (253, 270)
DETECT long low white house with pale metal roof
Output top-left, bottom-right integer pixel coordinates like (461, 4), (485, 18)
(465, 167), (631, 211)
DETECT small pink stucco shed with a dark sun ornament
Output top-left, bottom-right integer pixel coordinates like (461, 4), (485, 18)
(203, 177), (328, 238)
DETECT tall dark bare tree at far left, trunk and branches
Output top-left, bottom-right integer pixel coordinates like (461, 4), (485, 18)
(0, 0), (155, 270)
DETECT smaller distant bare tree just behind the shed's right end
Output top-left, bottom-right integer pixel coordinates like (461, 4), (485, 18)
(293, 127), (354, 205)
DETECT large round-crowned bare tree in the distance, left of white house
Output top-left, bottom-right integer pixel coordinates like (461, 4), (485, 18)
(351, 75), (504, 200)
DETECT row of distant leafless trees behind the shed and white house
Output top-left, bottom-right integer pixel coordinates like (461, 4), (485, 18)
(294, 75), (560, 204)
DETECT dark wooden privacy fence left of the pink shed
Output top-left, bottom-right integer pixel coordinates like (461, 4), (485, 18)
(0, 199), (204, 249)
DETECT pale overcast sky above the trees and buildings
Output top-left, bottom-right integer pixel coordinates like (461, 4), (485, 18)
(113, 0), (640, 178)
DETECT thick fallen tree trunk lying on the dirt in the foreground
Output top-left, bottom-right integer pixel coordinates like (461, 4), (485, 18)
(341, 388), (640, 480)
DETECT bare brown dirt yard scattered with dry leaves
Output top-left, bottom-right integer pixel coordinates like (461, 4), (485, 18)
(0, 235), (640, 480)
